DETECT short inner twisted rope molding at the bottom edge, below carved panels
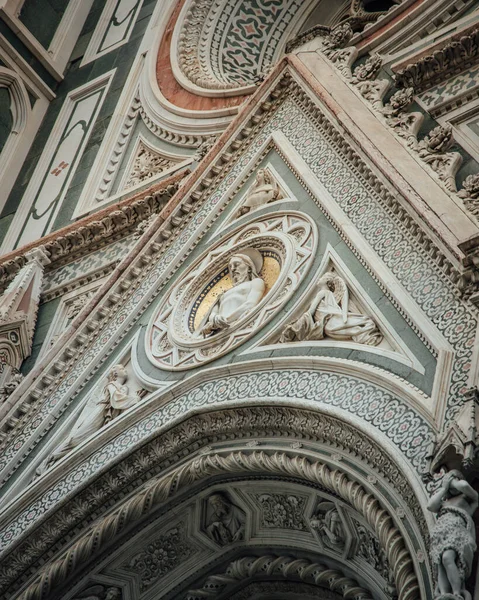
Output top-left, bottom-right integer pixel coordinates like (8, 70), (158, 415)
(185, 554), (373, 600)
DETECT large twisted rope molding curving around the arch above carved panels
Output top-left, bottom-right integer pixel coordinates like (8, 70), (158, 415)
(14, 452), (419, 600)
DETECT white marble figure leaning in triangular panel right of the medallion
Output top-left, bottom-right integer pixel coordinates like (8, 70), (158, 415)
(279, 271), (382, 346)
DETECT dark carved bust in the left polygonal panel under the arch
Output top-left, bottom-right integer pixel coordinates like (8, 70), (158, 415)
(206, 493), (245, 546)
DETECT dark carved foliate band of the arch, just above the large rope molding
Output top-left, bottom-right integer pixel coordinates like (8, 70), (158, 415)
(0, 406), (428, 589)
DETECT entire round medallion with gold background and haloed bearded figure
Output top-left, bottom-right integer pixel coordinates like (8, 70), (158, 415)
(146, 212), (317, 370)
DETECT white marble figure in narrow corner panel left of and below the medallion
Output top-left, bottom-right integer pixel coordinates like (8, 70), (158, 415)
(37, 364), (148, 475)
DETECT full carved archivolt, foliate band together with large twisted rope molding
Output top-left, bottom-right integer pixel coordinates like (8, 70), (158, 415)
(0, 398), (434, 600)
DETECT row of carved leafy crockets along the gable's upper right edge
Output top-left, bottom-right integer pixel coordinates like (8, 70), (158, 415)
(321, 25), (479, 225)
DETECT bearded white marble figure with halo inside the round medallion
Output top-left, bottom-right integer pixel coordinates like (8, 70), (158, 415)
(197, 248), (266, 337)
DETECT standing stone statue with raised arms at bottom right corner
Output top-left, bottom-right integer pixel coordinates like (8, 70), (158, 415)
(428, 470), (479, 600)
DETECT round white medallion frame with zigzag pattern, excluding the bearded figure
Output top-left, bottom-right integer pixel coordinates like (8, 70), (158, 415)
(145, 211), (318, 371)
